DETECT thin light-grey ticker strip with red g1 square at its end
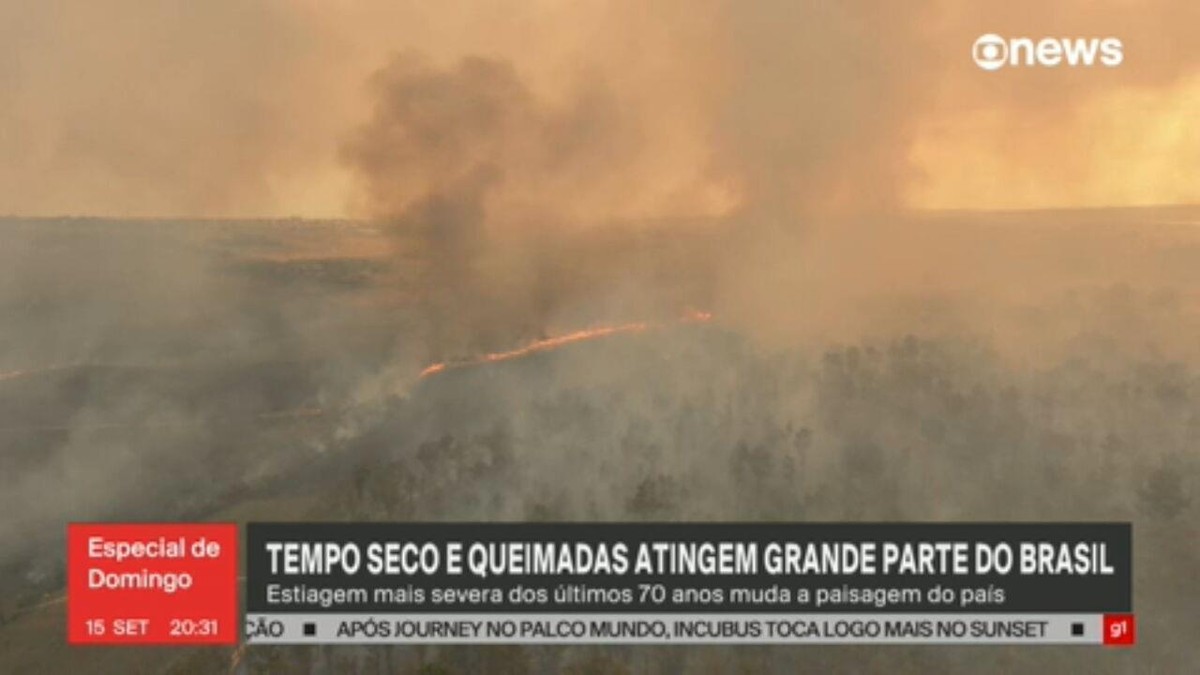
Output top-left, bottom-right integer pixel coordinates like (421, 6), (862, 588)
(245, 614), (1135, 646)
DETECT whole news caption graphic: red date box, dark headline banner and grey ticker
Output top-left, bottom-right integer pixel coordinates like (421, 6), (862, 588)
(67, 522), (1134, 645)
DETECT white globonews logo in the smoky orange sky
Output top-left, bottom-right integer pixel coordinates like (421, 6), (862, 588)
(971, 32), (1124, 71)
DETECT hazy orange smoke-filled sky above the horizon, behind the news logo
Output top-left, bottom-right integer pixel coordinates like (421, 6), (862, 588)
(0, 0), (1200, 220)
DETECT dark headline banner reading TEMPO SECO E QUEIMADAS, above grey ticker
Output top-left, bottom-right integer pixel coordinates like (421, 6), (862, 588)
(246, 522), (1133, 614)
